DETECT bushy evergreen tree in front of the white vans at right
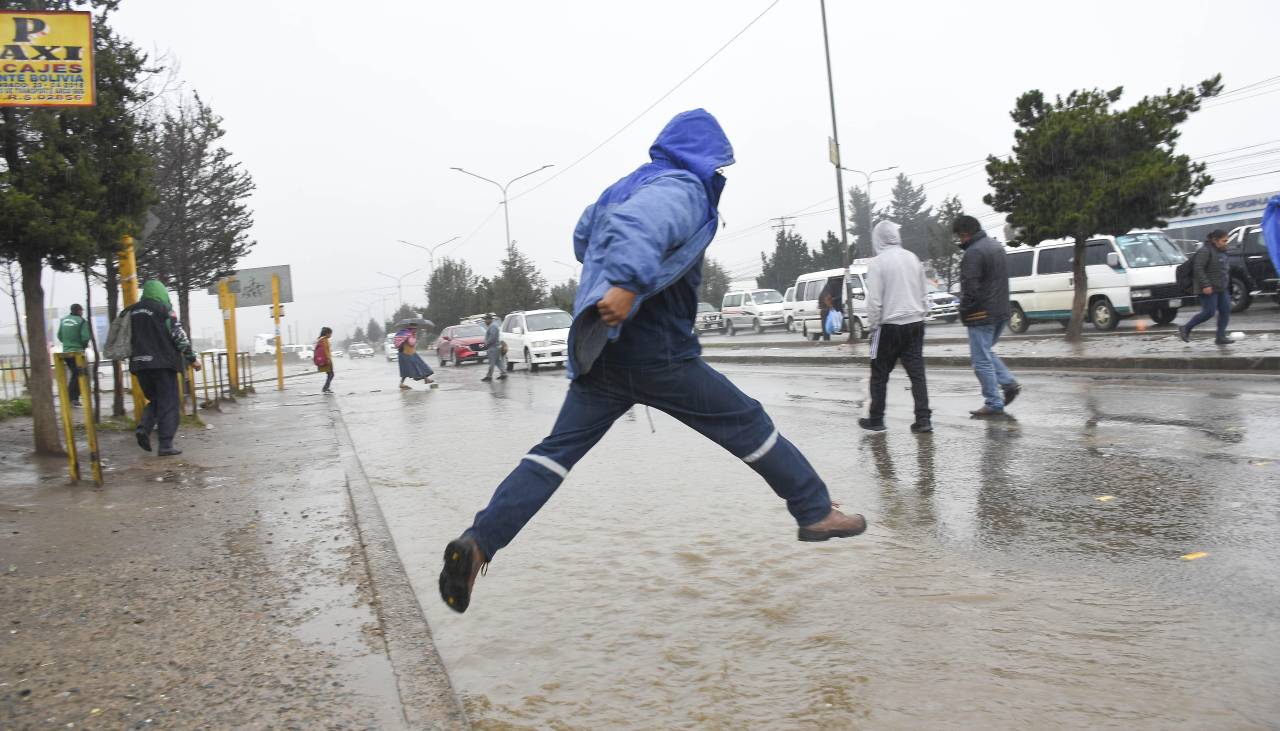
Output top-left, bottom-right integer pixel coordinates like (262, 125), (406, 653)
(983, 76), (1222, 341)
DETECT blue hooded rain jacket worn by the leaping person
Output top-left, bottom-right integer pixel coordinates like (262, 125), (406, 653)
(568, 109), (733, 379)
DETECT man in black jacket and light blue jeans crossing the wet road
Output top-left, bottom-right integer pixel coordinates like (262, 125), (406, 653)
(951, 215), (1023, 417)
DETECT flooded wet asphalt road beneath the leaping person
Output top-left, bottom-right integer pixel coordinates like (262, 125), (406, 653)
(322, 350), (1280, 728)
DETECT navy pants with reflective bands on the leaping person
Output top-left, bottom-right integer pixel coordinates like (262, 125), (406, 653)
(466, 358), (831, 558)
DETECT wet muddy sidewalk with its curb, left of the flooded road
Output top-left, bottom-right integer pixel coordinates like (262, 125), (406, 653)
(0, 392), (465, 728)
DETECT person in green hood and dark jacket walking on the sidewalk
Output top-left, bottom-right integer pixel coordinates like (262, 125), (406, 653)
(120, 279), (200, 457)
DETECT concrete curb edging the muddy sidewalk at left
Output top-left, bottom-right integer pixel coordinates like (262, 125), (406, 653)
(330, 407), (471, 731)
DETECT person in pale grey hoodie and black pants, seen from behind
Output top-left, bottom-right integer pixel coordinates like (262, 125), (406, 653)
(858, 220), (933, 433)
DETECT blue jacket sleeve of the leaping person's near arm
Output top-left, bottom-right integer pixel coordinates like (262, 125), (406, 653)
(599, 175), (707, 296)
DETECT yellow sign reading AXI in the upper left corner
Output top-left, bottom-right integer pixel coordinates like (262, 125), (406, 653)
(0, 10), (93, 106)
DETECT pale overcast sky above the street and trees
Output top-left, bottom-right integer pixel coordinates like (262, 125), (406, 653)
(3, 0), (1280, 346)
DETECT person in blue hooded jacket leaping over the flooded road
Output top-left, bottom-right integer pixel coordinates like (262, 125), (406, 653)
(440, 109), (867, 612)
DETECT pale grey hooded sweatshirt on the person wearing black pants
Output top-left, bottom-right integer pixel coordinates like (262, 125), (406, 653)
(867, 220), (929, 330)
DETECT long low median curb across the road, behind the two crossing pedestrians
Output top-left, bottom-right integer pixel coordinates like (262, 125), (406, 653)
(703, 353), (1280, 376)
